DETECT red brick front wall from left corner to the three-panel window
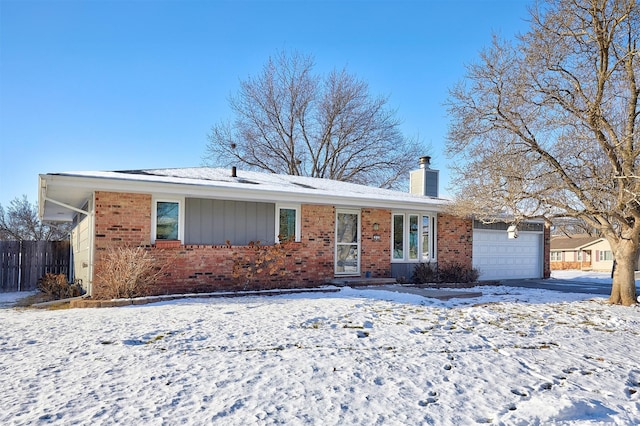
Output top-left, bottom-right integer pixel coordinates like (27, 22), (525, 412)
(88, 192), (391, 297)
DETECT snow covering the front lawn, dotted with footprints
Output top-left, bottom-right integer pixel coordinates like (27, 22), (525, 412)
(0, 274), (640, 425)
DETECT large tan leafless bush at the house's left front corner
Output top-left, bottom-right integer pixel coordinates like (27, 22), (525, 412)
(97, 247), (168, 299)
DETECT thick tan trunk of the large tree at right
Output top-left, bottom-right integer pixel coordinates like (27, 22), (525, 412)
(609, 239), (638, 306)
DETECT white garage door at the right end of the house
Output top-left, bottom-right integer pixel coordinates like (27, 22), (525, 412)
(473, 229), (542, 280)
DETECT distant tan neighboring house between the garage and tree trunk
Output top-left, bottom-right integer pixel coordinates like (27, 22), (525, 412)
(550, 234), (613, 271)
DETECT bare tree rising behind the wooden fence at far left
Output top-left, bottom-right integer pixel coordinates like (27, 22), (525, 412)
(0, 195), (71, 241)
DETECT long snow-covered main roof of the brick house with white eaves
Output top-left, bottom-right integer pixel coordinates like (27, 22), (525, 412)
(39, 167), (448, 221)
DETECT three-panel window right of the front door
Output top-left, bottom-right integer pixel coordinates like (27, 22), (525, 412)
(392, 213), (436, 262)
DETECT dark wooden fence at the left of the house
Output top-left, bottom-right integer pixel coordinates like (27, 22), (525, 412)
(0, 241), (70, 293)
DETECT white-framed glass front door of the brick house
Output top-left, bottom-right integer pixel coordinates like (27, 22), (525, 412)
(335, 210), (360, 276)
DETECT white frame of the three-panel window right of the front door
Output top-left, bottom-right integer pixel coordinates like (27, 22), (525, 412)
(390, 211), (438, 263)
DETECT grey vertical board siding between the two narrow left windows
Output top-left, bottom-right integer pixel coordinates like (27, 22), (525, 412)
(185, 198), (275, 245)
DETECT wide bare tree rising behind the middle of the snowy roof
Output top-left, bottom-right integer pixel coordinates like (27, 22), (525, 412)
(205, 52), (425, 188)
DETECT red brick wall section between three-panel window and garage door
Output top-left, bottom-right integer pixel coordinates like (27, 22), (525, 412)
(438, 213), (473, 269)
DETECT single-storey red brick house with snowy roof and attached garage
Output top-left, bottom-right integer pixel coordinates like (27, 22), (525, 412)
(39, 157), (549, 296)
